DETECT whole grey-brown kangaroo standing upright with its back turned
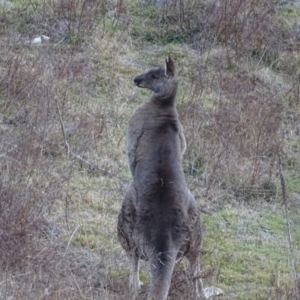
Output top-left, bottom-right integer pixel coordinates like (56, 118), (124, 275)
(118, 55), (223, 300)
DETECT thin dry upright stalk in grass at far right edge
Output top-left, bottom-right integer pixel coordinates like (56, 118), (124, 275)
(278, 153), (300, 300)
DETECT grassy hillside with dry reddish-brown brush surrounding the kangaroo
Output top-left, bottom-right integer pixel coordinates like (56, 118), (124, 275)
(0, 0), (300, 300)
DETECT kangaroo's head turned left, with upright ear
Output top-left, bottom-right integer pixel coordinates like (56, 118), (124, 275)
(134, 55), (177, 98)
